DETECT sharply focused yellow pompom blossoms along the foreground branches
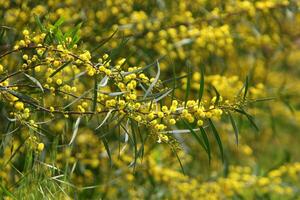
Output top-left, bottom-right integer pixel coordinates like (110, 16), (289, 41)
(1, 30), (246, 148)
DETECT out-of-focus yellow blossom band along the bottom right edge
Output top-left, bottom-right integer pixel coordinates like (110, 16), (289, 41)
(152, 160), (300, 199)
